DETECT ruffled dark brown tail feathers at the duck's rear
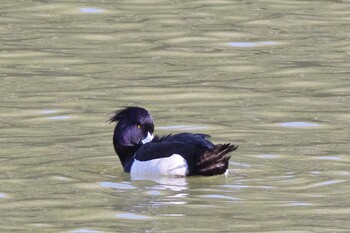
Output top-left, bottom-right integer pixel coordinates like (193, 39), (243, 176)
(194, 143), (238, 176)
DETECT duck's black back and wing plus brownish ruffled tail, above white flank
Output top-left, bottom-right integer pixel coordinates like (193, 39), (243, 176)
(135, 133), (237, 176)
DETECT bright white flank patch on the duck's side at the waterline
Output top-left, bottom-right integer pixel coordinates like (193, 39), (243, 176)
(130, 154), (188, 176)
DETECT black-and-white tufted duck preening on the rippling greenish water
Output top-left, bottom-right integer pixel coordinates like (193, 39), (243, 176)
(109, 107), (238, 177)
